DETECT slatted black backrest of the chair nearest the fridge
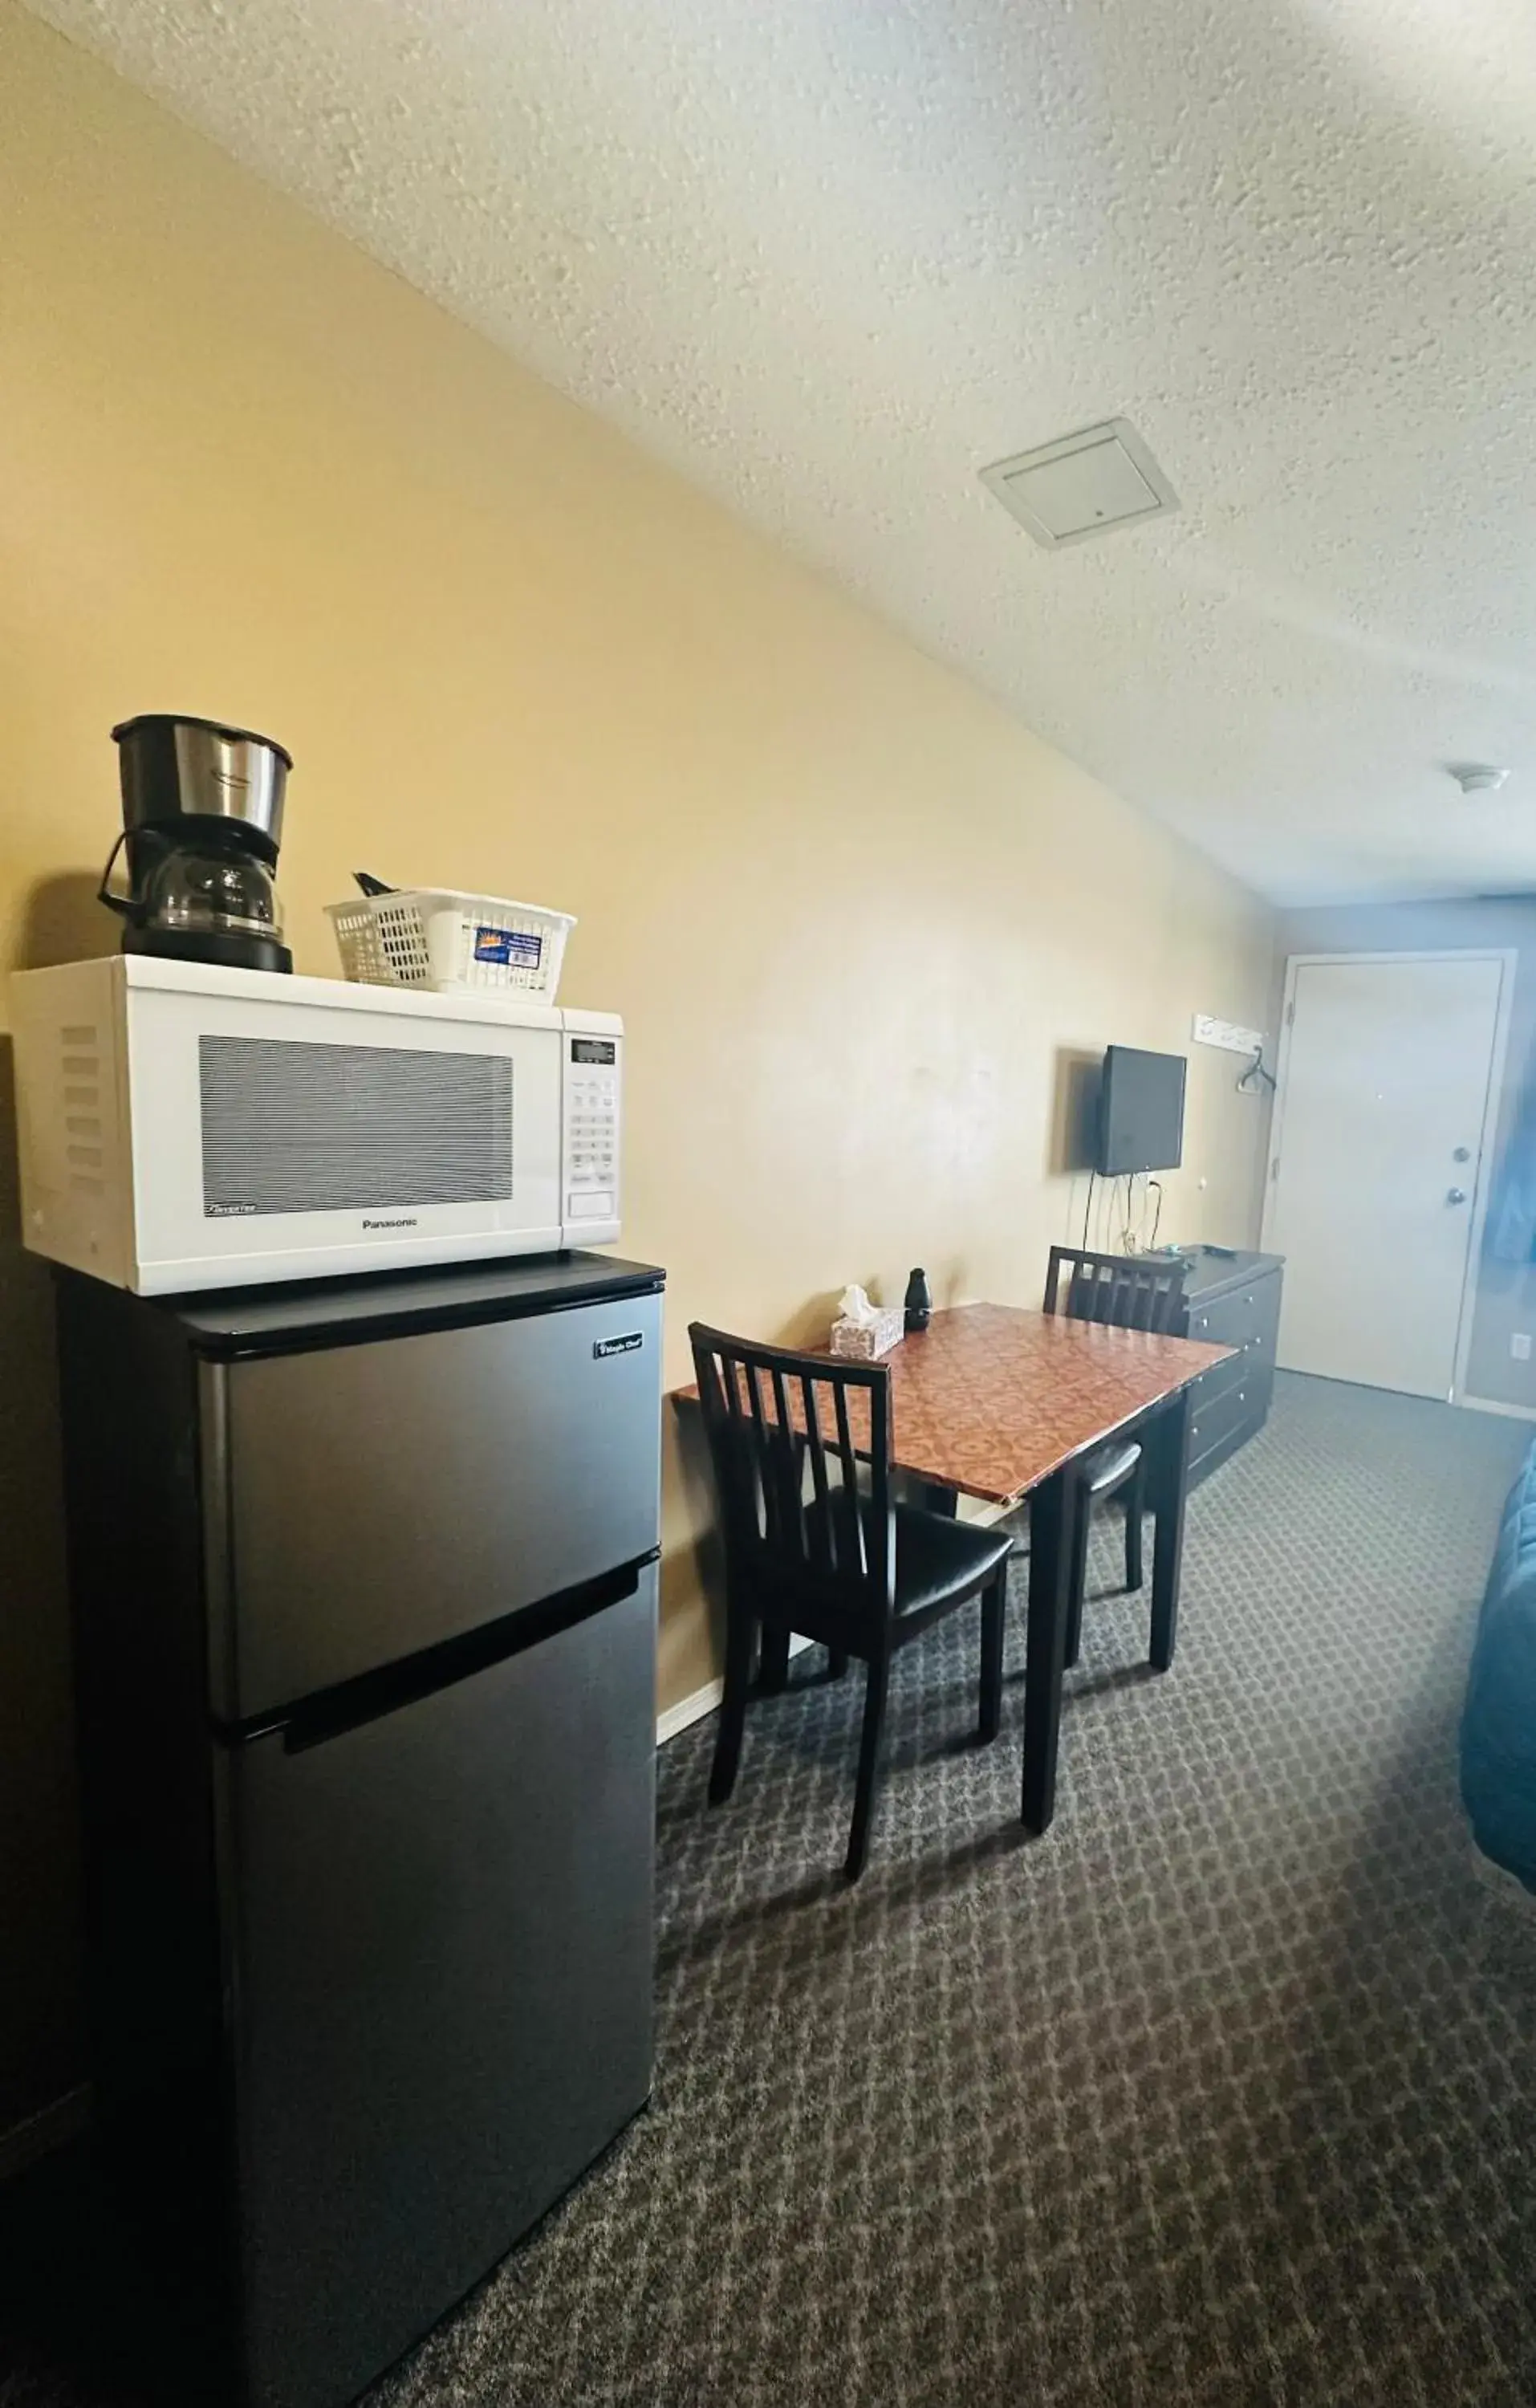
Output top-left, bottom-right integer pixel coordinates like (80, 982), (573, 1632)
(689, 1324), (896, 1611)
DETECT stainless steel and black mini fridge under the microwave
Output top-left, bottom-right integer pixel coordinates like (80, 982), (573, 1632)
(60, 1257), (662, 2408)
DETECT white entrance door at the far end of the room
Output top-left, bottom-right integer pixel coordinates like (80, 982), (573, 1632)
(1264, 954), (1505, 1397)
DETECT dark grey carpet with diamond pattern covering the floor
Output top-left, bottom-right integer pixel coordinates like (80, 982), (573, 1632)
(0, 1380), (1536, 2408)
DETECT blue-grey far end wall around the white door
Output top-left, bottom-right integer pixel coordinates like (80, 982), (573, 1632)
(1271, 896), (1536, 1411)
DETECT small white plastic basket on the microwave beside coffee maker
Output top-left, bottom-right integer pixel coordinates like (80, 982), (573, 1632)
(325, 886), (575, 1004)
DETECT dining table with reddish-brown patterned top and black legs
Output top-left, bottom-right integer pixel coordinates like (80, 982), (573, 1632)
(684, 1303), (1233, 1832)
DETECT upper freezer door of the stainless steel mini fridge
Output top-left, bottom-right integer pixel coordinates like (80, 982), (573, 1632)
(205, 1296), (662, 1722)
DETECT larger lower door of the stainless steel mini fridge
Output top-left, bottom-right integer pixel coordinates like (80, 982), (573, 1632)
(221, 1565), (655, 2408)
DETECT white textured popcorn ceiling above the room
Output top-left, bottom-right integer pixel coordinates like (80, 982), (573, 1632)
(26, 0), (1536, 898)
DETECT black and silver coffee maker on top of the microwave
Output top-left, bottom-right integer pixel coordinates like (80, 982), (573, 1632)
(101, 710), (294, 970)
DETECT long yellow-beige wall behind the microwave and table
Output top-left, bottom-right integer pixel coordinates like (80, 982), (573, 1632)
(0, 0), (1271, 2126)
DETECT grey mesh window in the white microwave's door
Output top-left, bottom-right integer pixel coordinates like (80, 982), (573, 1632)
(197, 1035), (513, 1221)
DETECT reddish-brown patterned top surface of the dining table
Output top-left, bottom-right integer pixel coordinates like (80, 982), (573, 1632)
(681, 1305), (1233, 1505)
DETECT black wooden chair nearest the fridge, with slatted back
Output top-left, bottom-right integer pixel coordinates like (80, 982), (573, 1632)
(689, 1322), (1011, 1881)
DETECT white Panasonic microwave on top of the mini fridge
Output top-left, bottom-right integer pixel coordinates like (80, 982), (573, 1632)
(12, 954), (624, 1296)
